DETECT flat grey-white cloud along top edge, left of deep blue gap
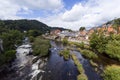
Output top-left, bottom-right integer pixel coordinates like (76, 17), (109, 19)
(12, 0), (63, 10)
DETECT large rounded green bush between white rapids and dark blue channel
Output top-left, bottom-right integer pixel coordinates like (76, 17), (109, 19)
(33, 36), (50, 57)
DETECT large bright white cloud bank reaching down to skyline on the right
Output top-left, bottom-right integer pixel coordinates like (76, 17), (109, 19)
(38, 0), (120, 30)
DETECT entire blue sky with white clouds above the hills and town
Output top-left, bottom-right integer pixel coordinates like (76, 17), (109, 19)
(0, 0), (120, 30)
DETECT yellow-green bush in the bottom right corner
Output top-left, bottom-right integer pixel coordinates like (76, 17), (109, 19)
(103, 65), (120, 80)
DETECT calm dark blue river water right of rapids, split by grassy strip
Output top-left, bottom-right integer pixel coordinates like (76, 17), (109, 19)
(42, 41), (102, 80)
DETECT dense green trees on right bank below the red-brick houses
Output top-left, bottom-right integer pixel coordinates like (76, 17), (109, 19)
(90, 30), (120, 61)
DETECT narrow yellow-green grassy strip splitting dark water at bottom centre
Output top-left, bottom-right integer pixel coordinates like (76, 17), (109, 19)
(71, 54), (88, 80)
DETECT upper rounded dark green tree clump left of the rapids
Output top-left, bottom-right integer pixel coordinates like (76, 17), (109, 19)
(0, 30), (23, 51)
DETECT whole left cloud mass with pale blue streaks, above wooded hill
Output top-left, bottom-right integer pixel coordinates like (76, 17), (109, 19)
(0, 0), (64, 19)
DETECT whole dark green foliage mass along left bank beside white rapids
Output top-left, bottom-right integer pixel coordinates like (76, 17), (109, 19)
(0, 28), (23, 65)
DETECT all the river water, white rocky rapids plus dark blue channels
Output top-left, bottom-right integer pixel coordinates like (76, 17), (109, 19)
(0, 41), (102, 80)
